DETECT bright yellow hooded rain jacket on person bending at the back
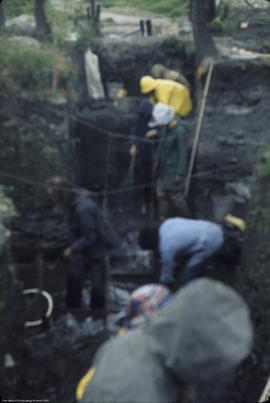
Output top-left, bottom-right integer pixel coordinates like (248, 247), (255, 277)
(140, 76), (192, 117)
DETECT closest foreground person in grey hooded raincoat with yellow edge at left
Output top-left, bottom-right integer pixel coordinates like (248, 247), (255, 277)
(77, 279), (253, 403)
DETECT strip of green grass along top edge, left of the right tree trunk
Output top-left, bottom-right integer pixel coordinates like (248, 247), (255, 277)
(100, 0), (189, 17)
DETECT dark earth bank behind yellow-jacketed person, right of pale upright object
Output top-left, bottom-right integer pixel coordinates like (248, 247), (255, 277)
(93, 36), (194, 96)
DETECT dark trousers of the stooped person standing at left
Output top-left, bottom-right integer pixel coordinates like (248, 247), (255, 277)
(66, 255), (106, 309)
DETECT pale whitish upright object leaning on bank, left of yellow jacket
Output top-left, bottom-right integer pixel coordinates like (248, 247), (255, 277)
(84, 49), (105, 100)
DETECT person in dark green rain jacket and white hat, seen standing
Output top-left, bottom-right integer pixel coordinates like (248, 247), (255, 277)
(149, 103), (190, 221)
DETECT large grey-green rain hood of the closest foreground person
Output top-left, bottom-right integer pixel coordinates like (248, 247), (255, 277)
(145, 279), (253, 383)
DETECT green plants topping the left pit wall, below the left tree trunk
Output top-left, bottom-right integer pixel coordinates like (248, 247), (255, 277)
(0, 39), (71, 95)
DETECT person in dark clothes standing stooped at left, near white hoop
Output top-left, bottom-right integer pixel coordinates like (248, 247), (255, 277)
(47, 177), (119, 310)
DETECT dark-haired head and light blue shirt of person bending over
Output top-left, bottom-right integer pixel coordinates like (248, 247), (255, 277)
(138, 217), (223, 287)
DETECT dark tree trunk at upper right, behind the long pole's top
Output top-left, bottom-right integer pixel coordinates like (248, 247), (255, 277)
(190, 0), (217, 65)
